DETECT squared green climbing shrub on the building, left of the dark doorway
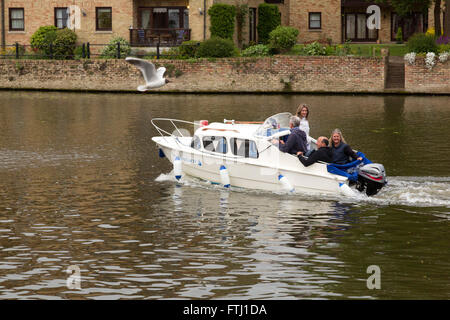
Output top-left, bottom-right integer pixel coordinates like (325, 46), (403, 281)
(208, 3), (236, 39)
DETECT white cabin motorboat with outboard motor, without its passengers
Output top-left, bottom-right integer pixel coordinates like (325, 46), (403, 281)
(152, 112), (386, 196)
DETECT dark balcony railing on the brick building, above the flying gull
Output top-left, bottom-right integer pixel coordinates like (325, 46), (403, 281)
(130, 28), (191, 47)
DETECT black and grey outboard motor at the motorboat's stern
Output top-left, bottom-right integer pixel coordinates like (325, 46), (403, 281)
(356, 163), (387, 196)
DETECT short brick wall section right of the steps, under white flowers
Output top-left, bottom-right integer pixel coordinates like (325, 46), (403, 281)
(405, 58), (450, 94)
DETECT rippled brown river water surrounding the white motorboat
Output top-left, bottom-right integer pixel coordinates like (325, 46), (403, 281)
(0, 92), (450, 299)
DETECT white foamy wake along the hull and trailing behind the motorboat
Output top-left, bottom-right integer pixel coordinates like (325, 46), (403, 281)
(155, 173), (450, 208)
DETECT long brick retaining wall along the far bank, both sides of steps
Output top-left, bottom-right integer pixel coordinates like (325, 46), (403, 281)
(0, 56), (450, 94)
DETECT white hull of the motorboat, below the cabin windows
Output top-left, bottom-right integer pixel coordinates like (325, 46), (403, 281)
(153, 137), (348, 195)
